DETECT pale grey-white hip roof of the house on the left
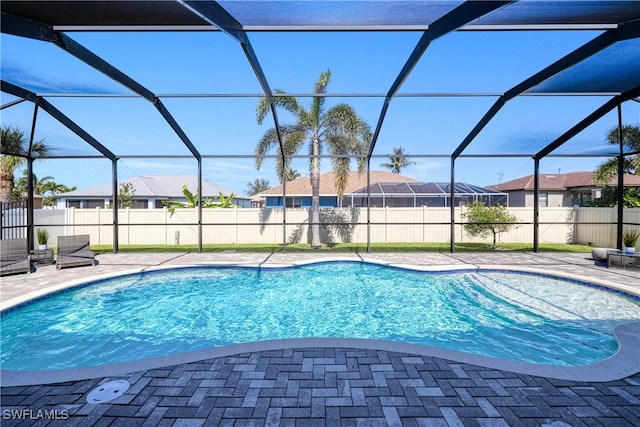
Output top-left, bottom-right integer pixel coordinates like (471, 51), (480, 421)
(56, 175), (246, 199)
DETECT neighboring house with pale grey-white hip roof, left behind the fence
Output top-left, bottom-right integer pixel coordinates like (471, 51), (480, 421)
(55, 175), (251, 209)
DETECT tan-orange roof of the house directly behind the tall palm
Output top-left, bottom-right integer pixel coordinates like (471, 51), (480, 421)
(257, 171), (417, 197)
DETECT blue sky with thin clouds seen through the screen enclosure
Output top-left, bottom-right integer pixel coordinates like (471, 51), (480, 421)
(1, 31), (640, 197)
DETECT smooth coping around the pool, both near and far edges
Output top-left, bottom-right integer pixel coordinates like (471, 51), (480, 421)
(0, 257), (640, 387)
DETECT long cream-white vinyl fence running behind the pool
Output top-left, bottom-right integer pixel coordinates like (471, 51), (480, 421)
(30, 207), (640, 247)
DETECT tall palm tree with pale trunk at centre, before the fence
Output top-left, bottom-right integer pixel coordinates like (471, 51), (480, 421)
(256, 70), (371, 248)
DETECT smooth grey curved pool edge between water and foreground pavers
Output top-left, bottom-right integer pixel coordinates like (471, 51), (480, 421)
(0, 322), (640, 387)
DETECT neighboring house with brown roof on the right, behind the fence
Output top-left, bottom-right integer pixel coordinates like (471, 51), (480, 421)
(487, 172), (640, 207)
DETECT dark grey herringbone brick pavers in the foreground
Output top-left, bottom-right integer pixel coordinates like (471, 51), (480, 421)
(1, 348), (640, 427)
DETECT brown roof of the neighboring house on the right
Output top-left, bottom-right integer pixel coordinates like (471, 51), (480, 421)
(487, 172), (640, 191)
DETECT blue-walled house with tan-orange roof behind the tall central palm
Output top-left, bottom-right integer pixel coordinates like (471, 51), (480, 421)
(256, 171), (417, 208)
